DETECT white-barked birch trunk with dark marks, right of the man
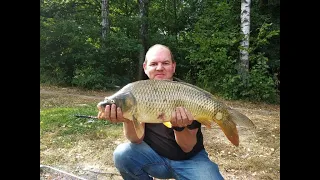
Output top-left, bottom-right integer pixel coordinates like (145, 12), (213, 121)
(238, 0), (251, 84)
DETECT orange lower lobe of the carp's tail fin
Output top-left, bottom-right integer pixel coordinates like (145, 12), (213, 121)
(217, 119), (239, 146)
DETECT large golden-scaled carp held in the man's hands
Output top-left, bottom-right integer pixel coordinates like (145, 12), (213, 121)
(97, 80), (254, 146)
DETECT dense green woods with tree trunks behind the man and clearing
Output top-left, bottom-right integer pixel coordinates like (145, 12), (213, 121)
(40, 0), (280, 103)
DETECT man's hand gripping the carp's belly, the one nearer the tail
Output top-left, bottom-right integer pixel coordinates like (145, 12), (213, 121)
(171, 107), (194, 127)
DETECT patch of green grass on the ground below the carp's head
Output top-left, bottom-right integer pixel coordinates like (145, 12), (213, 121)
(40, 104), (122, 147)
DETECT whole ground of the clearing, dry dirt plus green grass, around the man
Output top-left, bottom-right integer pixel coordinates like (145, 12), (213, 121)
(40, 86), (280, 179)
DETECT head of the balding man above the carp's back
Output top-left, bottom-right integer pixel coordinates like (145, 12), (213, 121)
(143, 47), (176, 80)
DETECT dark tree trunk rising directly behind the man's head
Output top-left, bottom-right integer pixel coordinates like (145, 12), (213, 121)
(138, 0), (148, 80)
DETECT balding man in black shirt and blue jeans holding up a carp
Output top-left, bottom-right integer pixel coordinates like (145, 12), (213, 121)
(101, 44), (223, 180)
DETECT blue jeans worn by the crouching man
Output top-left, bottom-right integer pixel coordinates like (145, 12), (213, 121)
(113, 142), (223, 180)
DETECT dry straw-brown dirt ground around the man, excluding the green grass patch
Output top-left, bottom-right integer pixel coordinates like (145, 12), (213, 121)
(40, 86), (280, 180)
